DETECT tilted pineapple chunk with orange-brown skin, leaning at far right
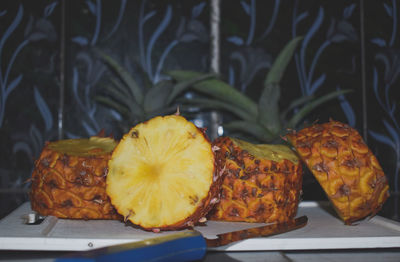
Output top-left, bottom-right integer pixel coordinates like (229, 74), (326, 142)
(286, 120), (389, 225)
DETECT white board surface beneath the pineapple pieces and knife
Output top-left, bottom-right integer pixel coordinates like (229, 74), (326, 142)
(0, 202), (400, 252)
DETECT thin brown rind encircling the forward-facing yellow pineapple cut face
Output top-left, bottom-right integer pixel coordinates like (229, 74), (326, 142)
(106, 115), (222, 233)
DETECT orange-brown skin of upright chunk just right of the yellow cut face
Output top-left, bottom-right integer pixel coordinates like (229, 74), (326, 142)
(209, 137), (303, 223)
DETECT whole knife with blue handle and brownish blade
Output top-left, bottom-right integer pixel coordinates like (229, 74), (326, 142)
(56, 216), (308, 262)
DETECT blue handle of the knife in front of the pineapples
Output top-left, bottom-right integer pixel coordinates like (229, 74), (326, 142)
(56, 231), (207, 262)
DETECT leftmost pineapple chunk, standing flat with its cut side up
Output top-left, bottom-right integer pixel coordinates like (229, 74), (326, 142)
(29, 137), (120, 219)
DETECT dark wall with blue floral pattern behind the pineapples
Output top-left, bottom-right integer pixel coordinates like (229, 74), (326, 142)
(0, 0), (400, 220)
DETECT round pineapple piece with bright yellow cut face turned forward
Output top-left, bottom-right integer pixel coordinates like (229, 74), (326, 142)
(107, 115), (219, 231)
